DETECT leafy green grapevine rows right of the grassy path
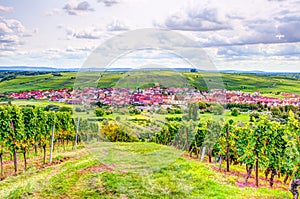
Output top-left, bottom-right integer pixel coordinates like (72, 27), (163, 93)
(154, 111), (300, 198)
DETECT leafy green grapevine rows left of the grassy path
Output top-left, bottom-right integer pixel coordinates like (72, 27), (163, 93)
(0, 105), (76, 179)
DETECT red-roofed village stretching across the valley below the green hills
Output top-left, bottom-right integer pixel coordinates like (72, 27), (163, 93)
(8, 86), (300, 106)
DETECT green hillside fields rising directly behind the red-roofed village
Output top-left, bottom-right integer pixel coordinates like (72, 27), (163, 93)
(0, 71), (300, 97)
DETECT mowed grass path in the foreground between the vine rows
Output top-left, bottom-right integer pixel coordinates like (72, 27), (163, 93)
(0, 143), (291, 199)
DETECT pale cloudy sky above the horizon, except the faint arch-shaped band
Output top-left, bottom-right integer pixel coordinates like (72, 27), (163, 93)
(0, 0), (300, 72)
